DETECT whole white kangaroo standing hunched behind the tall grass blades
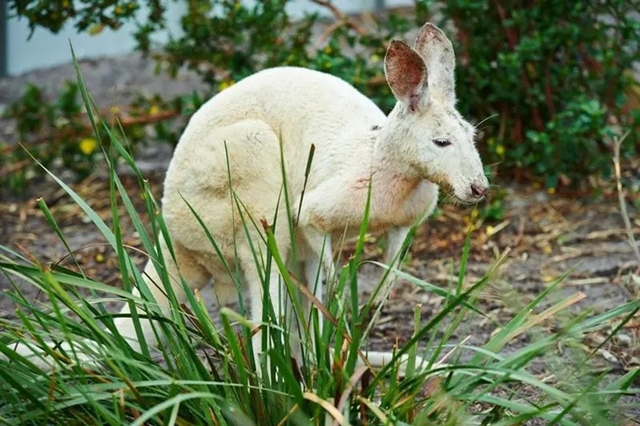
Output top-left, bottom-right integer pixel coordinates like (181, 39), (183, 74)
(6, 23), (489, 374)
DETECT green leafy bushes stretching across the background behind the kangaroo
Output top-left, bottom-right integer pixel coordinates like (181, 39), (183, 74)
(0, 0), (640, 187)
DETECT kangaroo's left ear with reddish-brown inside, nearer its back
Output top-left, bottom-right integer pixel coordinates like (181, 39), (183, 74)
(384, 40), (428, 112)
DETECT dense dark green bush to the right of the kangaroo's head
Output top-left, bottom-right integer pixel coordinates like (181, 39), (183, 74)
(442, 0), (640, 187)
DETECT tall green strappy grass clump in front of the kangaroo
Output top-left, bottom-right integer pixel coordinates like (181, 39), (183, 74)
(0, 51), (640, 426)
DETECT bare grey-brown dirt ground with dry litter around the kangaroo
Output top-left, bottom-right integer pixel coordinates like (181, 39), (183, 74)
(0, 54), (640, 422)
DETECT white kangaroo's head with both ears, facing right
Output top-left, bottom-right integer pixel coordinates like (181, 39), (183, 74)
(384, 23), (489, 203)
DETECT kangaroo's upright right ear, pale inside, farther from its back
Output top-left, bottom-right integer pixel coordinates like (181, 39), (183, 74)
(414, 22), (456, 103)
